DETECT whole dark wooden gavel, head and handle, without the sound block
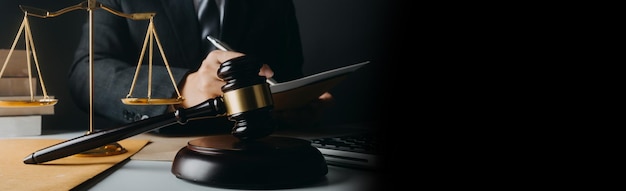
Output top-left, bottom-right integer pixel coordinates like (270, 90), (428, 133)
(24, 56), (275, 164)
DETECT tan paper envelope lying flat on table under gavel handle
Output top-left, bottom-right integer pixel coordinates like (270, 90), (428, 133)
(0, 138), (149, 191)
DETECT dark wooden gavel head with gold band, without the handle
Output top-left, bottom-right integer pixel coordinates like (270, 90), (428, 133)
(217, 56), (274, 140)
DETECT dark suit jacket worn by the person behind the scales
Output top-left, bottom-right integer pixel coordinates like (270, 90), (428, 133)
(69, 0), (303, 129)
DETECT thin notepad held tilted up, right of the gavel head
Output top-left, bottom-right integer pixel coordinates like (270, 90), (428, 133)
(270, 61), (369, 111)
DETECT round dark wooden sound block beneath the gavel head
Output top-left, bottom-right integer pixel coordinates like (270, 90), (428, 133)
(172, 135), (328, 189)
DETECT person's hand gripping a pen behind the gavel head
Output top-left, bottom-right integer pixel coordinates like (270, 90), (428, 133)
(180, 50), (274, 108)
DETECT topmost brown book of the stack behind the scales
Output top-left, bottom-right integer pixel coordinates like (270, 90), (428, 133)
(0, 49), (30, 78)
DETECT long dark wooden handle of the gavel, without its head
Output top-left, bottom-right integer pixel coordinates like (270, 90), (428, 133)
(24, 97), (226, 164)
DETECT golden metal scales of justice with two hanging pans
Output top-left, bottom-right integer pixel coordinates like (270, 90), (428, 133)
(0, 0), (179, 156)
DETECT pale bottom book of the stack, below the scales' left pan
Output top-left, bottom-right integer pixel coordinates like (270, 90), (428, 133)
(0, 115), (41, 137)
